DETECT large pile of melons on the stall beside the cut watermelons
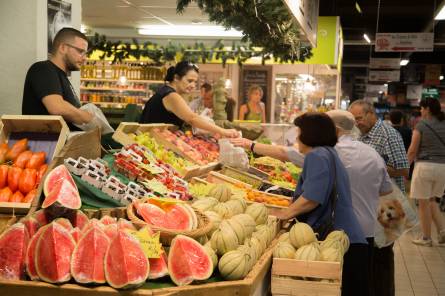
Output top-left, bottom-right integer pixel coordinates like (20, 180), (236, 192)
(192, 184), (277, 280)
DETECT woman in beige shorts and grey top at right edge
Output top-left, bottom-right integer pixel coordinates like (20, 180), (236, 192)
(408, 98), (445, 246)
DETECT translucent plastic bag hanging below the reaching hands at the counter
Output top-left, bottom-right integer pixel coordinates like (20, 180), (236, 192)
(218, 139), (249, 170)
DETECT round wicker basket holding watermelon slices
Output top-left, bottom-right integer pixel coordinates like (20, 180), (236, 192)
(127, 203), (212, 246)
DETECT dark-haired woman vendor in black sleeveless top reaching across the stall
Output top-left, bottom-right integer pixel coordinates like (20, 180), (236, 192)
(140, 61), (239, 138)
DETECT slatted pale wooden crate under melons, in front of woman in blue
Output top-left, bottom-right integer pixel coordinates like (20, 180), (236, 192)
(271, 258), (342, 296)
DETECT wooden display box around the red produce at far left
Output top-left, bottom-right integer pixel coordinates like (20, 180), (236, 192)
(0, 115), (69, 214)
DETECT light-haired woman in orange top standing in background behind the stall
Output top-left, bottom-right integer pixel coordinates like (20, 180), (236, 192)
(238, 84), (266, 123)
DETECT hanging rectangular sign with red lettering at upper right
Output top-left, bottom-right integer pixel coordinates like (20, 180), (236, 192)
(375, 33), (434, 52)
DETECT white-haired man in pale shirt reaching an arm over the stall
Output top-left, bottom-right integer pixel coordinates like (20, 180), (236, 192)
(231, 110), (392, 295)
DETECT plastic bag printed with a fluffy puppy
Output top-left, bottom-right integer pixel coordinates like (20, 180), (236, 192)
(374, 181), (419, 248)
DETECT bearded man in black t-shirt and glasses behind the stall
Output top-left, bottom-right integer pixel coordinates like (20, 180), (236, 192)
(22, 28), (93, 130)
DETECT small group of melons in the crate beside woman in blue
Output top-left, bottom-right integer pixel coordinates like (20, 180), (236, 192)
(273, 222), (349, 262)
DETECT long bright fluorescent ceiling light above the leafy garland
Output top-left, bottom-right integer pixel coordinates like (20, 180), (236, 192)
(138, 25), (243, 38)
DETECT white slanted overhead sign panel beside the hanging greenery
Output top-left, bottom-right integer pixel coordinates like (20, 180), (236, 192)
(283, 0), (319, 47)
